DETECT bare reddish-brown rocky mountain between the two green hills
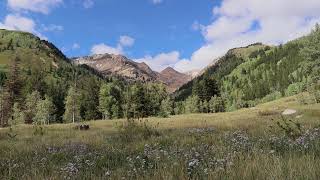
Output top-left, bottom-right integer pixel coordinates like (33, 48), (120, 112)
(72, 54), (191, 92)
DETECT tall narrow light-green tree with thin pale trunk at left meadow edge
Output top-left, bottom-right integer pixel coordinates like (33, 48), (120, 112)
(63, 86), (81, 123)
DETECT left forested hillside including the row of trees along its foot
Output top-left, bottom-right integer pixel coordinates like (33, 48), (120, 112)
(0, 30), (173, 126)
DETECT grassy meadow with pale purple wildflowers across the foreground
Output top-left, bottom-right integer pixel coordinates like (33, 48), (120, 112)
(0, 96), (320, 179)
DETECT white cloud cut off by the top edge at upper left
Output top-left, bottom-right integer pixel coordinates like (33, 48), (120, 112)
(8, 0), (63, 14)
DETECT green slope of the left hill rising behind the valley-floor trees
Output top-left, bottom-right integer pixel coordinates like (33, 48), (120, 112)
(0, 30), (103, 121)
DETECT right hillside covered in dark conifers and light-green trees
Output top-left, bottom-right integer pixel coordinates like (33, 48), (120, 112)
(174, 25), (320, 110)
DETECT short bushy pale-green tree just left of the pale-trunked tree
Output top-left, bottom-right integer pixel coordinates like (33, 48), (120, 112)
(33, 96), (55, 125)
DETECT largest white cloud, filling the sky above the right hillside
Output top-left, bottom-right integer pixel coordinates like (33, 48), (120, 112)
(174, 0), (320, 71)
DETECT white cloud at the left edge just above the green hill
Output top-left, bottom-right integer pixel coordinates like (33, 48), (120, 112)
(0, 14), (47, 39)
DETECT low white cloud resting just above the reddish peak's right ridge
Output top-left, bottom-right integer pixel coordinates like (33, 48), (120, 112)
(135, 51), (185, 72)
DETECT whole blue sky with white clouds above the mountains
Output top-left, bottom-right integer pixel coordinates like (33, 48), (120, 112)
(0, 0), (320, 72)
